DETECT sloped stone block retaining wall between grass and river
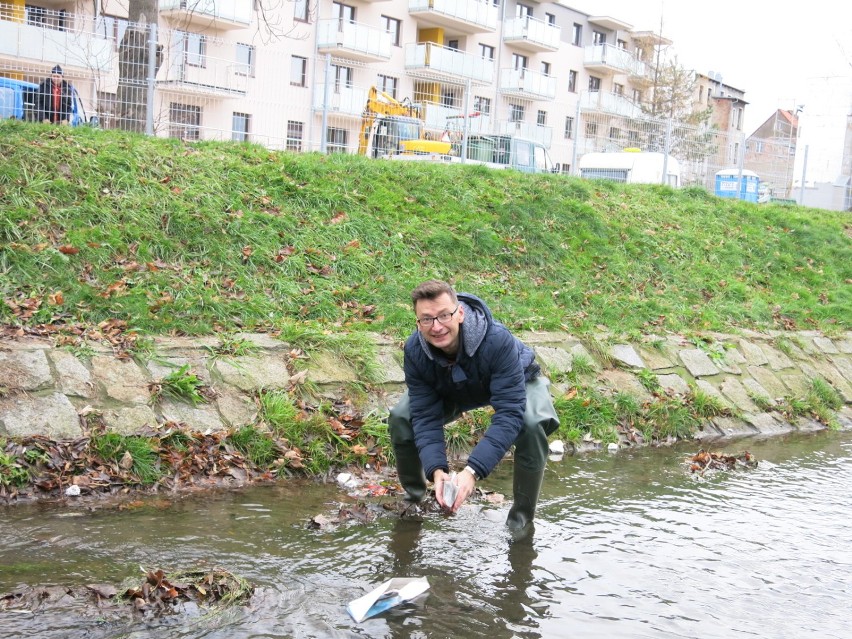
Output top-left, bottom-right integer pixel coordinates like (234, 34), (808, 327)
(0, 332), (852, 439)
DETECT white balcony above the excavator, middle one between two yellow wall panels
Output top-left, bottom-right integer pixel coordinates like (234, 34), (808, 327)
(405, 42), (494, 84)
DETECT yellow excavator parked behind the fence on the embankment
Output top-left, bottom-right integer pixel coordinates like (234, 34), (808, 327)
(358, 87), (451, 158)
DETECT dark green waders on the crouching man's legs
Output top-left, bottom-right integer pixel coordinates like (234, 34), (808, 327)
(388, 376), (559, 531)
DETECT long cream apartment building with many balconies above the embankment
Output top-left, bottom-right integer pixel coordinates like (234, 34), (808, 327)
(0, 0), (671, 172)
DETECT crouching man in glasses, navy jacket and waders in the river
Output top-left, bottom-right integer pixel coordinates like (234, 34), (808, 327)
(388, 280), (559, 533)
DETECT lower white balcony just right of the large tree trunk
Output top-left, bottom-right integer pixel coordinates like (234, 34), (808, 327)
(157, 52), (249, 98)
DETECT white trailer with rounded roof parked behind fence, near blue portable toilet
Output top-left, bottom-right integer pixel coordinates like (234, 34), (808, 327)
(580, 151), (680, 187)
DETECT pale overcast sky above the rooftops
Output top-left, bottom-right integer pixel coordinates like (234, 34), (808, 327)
(561, 0), (852, 182)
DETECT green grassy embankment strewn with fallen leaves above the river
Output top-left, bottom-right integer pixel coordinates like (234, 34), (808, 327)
(0, 122), (852, 492)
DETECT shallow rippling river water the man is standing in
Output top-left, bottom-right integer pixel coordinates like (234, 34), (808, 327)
(0, 432), (852, 639)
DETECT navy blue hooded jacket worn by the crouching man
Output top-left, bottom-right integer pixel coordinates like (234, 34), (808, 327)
(404, 293), (541, 480)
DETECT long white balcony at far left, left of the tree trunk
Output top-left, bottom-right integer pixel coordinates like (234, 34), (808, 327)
(0, 5), (115, 77)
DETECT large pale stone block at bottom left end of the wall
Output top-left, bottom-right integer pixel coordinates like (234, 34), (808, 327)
(0, 393), (83, 439)
